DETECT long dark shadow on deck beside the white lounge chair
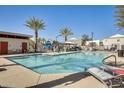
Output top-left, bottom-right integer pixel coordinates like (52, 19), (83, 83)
(30, 72), (89, 88)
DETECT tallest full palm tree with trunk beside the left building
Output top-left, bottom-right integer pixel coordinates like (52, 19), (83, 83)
(26, 17), (45, 52)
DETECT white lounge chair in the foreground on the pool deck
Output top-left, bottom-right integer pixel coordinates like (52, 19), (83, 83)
(87, 67), (122, 87)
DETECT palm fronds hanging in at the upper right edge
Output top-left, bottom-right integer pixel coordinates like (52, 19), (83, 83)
(115, 5), (124, 30)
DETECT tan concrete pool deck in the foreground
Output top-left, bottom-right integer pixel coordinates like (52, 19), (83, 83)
(0, 53), (124, 88)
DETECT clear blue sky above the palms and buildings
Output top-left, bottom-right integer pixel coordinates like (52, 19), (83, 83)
(0, 5), (124, 40)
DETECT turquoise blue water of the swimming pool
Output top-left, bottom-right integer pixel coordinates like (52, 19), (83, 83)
(7, 52), (106, 74)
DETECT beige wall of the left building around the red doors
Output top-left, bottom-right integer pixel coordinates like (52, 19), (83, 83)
(0, 38), (29, 52)
